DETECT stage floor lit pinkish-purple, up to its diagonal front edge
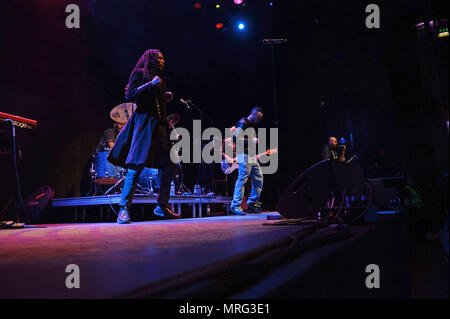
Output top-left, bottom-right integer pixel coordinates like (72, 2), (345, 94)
(0, 213), (312, 298)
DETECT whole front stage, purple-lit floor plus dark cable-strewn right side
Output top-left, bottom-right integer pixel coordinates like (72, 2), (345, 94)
(0, 212), (409, 299)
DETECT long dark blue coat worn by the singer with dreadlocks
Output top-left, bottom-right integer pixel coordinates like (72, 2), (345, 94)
(108, 69), (170, 168)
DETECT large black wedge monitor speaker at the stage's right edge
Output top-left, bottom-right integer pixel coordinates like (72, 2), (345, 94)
(276, 160), (366, 218)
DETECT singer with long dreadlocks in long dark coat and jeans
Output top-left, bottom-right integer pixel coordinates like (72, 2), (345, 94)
(108, 49), (179, 224)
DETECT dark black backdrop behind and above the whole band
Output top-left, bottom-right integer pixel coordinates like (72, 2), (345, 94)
(0, 0), (448, 225)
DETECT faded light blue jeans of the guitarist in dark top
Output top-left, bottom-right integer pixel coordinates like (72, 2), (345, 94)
(231, 156), (263, 207)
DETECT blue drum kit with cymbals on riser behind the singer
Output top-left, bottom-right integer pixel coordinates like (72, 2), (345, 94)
(90, 103), (182, 195)
